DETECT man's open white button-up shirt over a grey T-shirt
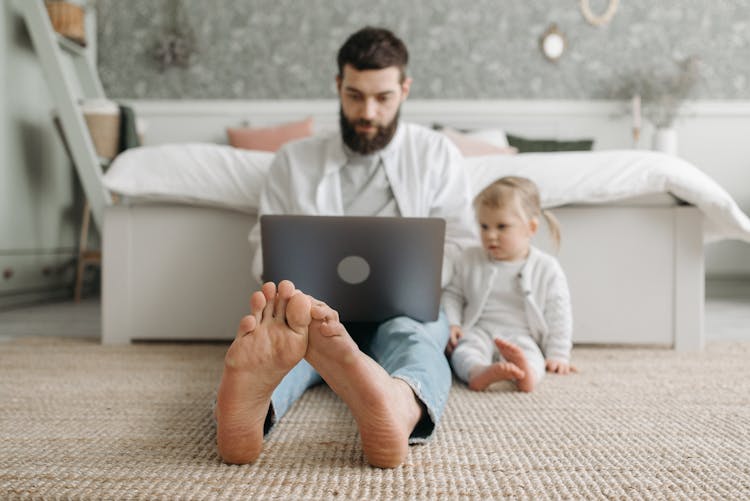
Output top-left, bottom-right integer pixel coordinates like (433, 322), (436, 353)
(249, 123), (477, 286)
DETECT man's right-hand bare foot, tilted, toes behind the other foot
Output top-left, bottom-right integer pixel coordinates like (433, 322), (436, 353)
(305, 300), (422, 468)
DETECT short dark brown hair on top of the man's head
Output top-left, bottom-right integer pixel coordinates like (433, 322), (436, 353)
(337, 26), (409, 82)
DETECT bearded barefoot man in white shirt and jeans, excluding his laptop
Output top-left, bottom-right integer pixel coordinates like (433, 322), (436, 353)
(216, 27), (475, 468)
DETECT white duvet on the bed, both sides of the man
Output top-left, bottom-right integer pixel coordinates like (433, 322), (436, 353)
(104, 143), (750, 242)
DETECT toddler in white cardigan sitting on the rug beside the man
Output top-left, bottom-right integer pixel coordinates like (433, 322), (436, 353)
(443, 176), (576, 392)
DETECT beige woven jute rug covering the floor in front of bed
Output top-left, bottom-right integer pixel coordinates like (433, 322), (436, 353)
(0, 338), (750, 500)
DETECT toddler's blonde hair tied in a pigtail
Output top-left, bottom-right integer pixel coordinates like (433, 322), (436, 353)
(474, 176), (560, 249)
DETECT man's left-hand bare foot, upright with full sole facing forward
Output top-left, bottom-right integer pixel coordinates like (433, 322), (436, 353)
(216, 280), (310, 464)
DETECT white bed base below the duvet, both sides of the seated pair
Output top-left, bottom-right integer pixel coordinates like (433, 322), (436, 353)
(102, 201), (704, 350)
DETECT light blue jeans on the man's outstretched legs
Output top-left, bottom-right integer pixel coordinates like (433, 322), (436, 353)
(264, 311), (451, 444)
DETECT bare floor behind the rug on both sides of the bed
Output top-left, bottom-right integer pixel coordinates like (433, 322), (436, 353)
(0, 280), (750, 341)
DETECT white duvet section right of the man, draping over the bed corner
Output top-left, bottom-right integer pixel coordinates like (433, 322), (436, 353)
(466, 150), (750, 242)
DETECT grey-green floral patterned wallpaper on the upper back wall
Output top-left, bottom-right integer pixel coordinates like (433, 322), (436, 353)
(95, 0), (750, 99)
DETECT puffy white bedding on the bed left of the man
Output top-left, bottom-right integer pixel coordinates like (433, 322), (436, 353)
(104, 143), (274, 213)
